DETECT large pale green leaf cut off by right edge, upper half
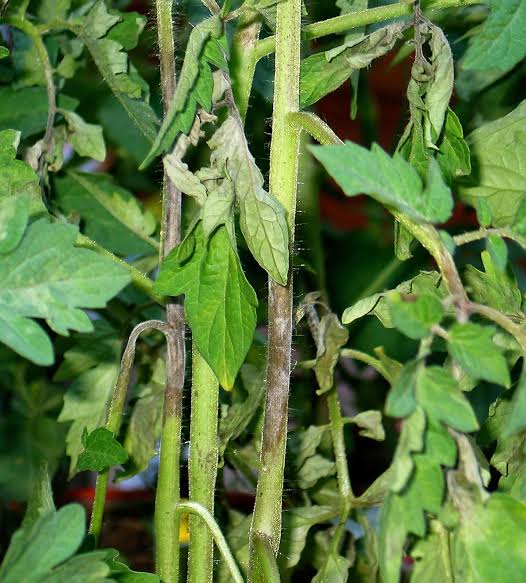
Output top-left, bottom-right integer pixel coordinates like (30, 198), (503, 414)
(460, 100), (526, 227)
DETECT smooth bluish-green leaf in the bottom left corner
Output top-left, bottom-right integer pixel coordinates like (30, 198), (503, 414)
(0, 504), (85, 583)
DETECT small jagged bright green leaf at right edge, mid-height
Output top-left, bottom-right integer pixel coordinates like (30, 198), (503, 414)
(465, 251), (524, 321)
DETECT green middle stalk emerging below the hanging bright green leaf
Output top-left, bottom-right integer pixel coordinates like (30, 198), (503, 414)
(188, 344), (219, 583)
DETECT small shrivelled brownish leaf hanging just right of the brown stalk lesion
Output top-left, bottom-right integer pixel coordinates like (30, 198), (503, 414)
(314, 313), (349, 395)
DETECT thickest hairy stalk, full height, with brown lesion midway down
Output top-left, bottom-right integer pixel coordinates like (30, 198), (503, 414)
(249, 0), (301, 582)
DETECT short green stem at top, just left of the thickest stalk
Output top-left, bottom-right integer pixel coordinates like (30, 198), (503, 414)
(230, 0), (263, 121)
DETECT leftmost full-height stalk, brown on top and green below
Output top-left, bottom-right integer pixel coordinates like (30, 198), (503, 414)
(154, 0), (185, 583)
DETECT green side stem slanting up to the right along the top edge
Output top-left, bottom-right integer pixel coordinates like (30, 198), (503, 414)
(254, 0), (483, 61)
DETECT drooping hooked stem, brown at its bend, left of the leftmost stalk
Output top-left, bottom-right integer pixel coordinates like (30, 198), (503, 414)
(89, 320), (172, 542)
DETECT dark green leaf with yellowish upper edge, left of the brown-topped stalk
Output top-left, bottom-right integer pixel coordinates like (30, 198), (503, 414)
(55, 172), (158, 256)
